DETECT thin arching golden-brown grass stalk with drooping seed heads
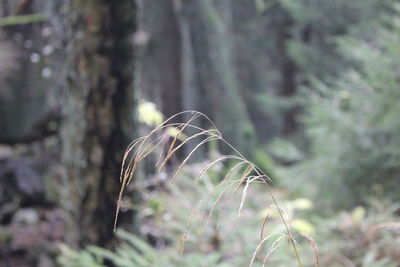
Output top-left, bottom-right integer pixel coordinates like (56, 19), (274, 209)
(114, 111), (308, 267)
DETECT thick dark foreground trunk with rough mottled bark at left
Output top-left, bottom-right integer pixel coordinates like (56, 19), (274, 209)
(62, 0), (136, 249)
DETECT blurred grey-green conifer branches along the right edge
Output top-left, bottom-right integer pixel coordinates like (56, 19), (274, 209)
(300, 6), (400, 207)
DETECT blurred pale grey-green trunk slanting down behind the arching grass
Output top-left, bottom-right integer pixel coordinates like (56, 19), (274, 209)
(176, 0), (254, 156)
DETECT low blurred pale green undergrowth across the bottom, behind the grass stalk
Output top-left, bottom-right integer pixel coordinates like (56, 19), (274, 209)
(60, 162), (400, 267)
